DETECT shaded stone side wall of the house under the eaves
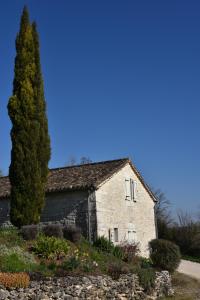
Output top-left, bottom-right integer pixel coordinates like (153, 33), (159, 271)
(0, 191), (90, 238)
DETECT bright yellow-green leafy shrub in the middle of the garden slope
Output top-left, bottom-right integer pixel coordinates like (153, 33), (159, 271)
(32, 235), (69, 259)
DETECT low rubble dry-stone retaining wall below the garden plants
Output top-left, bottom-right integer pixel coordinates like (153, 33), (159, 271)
(0, 272), (173, 300)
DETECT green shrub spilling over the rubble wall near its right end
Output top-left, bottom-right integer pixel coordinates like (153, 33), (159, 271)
(137, 269), (155, 293)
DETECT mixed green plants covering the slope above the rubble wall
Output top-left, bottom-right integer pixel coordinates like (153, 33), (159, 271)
(0, 226), (162, 290)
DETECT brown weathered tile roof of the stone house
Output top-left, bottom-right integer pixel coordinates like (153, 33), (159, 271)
(0, 158), (155, 201)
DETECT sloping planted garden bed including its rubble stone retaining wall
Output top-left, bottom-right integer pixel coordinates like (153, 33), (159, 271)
(0, 226), (172, 299)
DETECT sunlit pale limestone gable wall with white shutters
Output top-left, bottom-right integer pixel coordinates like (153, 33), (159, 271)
(96, 164), (156, 256)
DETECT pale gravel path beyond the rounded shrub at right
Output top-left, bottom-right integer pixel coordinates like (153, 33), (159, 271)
(177, 260), (200, 279)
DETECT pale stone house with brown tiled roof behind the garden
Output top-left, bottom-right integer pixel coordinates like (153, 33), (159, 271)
(0, 158), (156, 256)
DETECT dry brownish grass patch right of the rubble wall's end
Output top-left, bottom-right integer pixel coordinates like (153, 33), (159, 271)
(162, 272), (200, 300)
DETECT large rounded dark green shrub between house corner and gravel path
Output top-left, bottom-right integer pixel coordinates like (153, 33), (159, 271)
(149, 239), (181, 272)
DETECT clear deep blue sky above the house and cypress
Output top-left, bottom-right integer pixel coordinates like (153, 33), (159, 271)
(0, 0), (200, 212)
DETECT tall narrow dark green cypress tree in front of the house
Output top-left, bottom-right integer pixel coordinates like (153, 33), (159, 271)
(8, 7), (50, 227)
